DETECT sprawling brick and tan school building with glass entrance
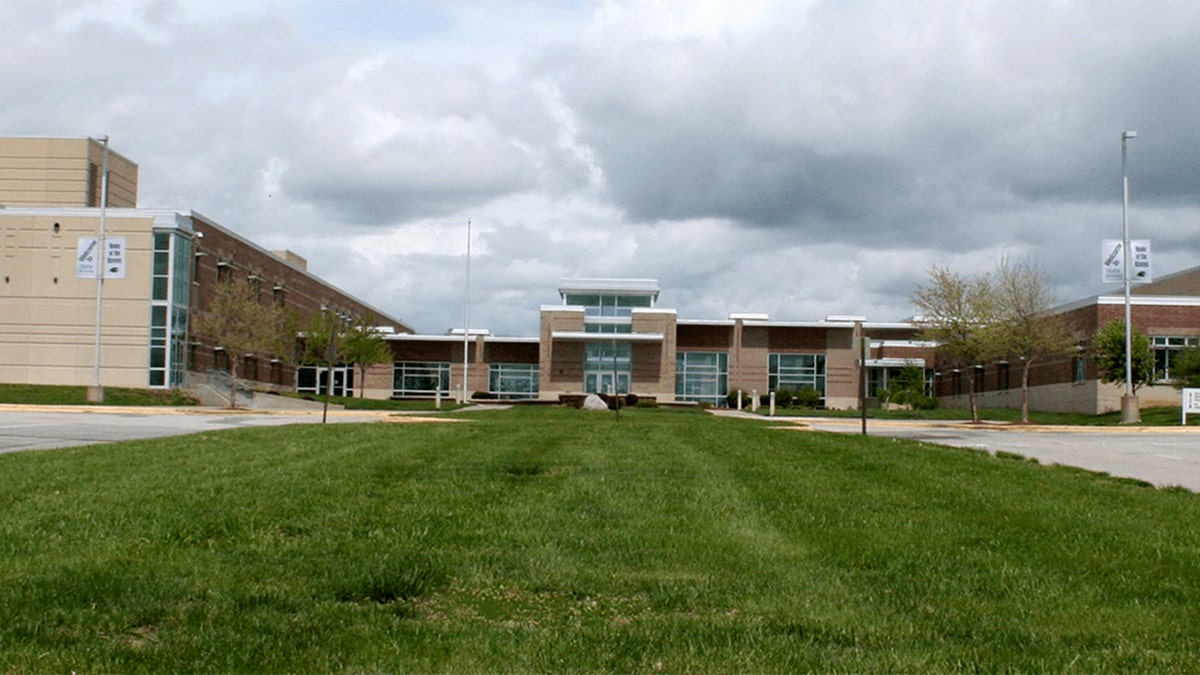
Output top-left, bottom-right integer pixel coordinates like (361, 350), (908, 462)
(0, 138), (1200, 413)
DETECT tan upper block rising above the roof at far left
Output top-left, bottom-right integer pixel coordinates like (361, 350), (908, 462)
(0, 138), (138, 208)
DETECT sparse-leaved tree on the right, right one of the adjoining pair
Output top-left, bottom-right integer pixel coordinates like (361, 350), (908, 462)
(992, 258), (1075, 424)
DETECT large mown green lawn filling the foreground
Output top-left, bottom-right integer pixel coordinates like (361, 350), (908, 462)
(0, 407), (1200, 673)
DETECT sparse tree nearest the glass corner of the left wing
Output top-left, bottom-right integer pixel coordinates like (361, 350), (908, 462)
(196, 281), (295, 408)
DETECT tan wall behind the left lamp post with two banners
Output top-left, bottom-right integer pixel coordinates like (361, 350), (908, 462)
(0, 213), (152, 388)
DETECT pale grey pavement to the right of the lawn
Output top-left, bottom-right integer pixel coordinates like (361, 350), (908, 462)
(712, 410), (1200, 491)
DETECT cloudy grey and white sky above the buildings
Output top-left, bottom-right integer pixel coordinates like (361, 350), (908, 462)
(0, 0), (1200, 335)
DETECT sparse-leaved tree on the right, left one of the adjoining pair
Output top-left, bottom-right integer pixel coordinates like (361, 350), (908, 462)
(912, 265), (1000, 423)
